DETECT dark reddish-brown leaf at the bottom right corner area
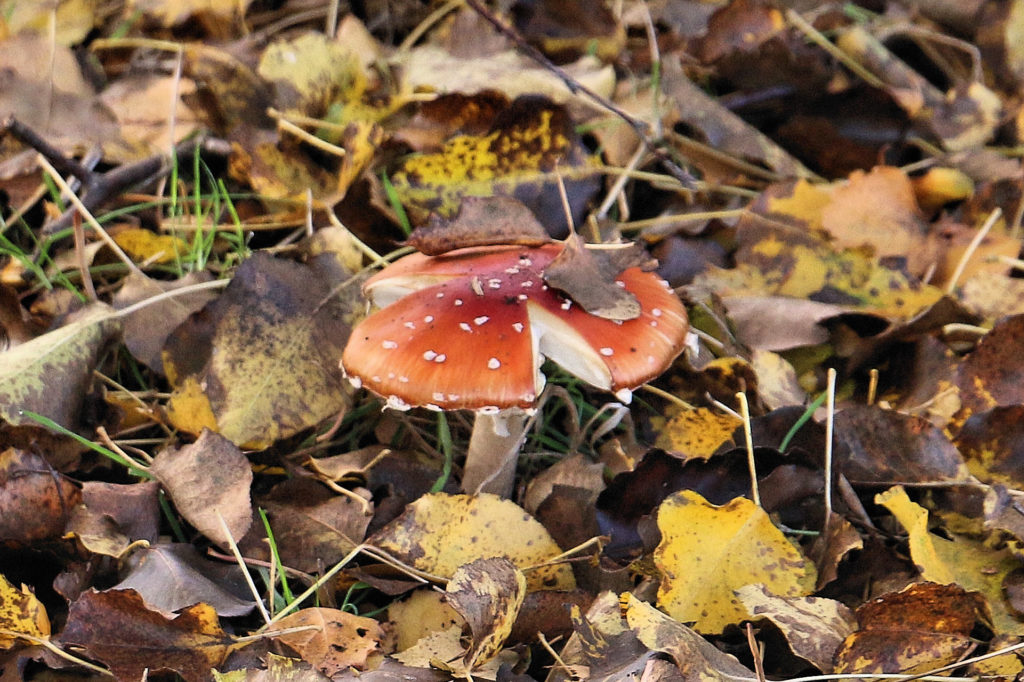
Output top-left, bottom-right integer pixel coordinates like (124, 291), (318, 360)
(836, 583), (987, 675)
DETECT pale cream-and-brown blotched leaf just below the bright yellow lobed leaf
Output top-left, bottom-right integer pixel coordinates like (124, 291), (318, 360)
(736, 585), (856, 673)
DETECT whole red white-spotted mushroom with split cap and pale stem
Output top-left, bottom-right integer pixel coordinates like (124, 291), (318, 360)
(341, 244), (688, 496)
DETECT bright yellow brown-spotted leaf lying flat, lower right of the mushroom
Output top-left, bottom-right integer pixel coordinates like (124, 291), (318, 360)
(654, 491), (815, 633)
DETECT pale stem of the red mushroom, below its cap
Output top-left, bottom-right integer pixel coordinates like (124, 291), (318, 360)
(462, 408), (528, 498)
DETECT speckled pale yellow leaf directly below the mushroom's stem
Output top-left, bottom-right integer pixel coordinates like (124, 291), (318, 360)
(368, 493), (575, 592)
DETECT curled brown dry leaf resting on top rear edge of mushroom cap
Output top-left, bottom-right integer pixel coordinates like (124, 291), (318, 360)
(406, 197), (552, 256)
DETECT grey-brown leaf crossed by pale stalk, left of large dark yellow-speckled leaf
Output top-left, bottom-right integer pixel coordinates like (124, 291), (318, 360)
(114, 272), (216, 373)
